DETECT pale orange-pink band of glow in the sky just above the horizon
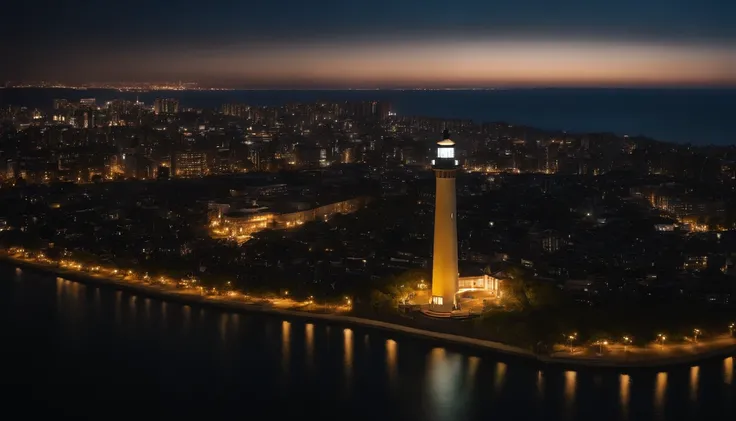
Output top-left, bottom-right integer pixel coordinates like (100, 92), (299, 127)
(36, 39), (736, 88)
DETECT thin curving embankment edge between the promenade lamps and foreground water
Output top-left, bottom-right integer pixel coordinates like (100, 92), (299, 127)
(0, 255), (736, 369)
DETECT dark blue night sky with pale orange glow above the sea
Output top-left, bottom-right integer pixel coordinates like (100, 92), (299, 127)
(0, 0), (736, 88)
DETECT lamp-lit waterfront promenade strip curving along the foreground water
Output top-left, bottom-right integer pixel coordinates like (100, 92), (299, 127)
(0, 252), (736, 368)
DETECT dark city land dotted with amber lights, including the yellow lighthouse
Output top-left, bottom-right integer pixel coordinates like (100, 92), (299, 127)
(0, 95), (736, 343)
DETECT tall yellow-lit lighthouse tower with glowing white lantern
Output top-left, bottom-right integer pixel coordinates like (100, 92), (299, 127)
(429, 130), (458, 313)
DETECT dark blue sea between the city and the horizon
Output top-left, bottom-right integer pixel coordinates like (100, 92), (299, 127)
(0, 89), (736, 145)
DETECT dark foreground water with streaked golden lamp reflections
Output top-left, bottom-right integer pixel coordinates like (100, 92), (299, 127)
(0, 266), (736, 421)
